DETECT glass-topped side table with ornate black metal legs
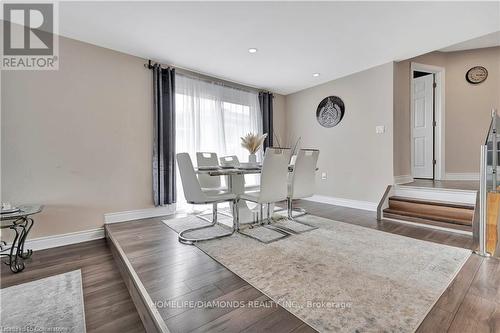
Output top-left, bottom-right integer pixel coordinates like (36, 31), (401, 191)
(0, 205), (43, 273)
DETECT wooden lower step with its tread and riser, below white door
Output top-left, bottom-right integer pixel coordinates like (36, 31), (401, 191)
(383, 196), (474, 231)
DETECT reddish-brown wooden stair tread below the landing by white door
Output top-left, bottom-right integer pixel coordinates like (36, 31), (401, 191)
(389, 200), (474, 223)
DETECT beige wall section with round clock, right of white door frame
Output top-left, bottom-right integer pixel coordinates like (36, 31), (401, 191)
(446, 47), (500, 173)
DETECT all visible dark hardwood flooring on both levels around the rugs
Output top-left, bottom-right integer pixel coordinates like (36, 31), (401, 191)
(0, 201), (500, 333)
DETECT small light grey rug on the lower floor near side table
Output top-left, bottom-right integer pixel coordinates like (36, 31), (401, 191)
(0, 270), (86, 333)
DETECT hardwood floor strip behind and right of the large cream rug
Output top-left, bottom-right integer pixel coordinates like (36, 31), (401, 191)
(296, 200), (500, 333)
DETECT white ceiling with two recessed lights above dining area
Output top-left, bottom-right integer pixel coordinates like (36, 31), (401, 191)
(59, 2), (500, 94)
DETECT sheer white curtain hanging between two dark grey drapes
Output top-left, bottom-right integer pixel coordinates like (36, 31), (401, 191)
(175, 74), (262, 203)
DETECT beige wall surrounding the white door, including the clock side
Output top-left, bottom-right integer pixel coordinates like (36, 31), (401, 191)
(394, 47), (500, 176)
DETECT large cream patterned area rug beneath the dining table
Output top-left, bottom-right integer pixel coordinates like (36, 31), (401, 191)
(164, 215), (471, 332)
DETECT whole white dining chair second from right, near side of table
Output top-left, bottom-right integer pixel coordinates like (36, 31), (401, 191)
(240, 148), (290, 241)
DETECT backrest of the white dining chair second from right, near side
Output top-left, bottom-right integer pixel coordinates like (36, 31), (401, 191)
(259, 148), (291, 203)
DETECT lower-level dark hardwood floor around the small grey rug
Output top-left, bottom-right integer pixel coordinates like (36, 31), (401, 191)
(0, 239), (145, 333)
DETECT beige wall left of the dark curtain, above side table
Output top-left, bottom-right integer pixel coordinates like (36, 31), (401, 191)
(1, 38), (153, 238)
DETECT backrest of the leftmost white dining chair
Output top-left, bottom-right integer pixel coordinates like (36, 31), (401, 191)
(177, 153), (206, 204)
